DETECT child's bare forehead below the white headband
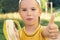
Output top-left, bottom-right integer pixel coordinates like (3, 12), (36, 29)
(21, 0), (38, 7)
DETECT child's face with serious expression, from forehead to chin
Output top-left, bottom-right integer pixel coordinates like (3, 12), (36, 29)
(19, 0), (40, 25)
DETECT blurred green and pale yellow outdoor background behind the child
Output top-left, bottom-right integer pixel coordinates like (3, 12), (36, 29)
(0, 0), (60, 40)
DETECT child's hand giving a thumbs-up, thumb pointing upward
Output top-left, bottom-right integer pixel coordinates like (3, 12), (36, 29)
(46, 15), (59, 39)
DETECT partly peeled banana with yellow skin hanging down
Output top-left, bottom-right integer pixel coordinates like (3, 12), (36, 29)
(3, 20), (21, 40)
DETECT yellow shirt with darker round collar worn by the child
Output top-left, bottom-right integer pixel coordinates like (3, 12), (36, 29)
(20, 25), (48, 40)
